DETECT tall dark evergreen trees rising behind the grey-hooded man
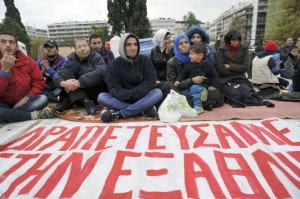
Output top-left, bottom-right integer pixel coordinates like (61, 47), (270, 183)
(107, 0), (151, 38)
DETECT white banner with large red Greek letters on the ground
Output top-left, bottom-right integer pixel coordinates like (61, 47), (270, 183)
(0, 118), (300, 199)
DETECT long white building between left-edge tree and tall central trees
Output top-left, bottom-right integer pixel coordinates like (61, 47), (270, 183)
(48, 20), (108, 42)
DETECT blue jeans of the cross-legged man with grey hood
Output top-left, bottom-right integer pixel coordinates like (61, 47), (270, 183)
(97, 88), (163, 118)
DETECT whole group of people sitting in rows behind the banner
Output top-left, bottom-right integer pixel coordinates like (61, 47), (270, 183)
(0, 29), (300, 122)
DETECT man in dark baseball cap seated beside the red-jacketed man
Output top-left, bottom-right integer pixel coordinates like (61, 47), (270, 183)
(37, 39), (67, 102)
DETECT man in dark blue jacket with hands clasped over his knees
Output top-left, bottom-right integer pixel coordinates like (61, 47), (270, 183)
(54, 39), (107, 115)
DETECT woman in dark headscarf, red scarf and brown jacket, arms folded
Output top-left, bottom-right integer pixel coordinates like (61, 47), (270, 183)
(216, 30), (274, 107)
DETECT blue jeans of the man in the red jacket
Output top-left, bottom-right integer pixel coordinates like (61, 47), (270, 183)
(0, 95), (48, 122)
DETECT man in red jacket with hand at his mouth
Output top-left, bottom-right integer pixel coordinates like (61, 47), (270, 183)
(0, 32), (53, 122)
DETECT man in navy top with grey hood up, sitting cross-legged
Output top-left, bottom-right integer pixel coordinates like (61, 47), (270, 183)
(97, 33), (163, 122)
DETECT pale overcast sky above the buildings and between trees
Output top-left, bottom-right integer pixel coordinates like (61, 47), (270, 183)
(0, 0), (246, 29)
